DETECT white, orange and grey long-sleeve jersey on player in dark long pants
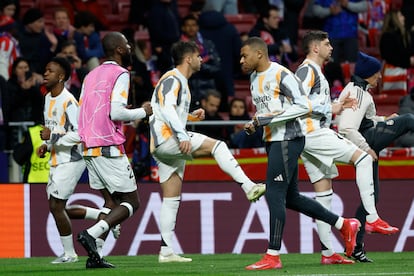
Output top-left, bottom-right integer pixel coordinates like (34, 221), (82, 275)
(250, 62), (311, 142)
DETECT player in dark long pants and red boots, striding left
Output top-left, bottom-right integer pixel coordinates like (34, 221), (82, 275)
(240, 37), (360, 270)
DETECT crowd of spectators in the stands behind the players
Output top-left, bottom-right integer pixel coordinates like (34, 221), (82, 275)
(0, 0), (414, 182)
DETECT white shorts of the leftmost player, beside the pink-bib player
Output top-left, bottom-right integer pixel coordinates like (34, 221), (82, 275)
(46, 159), (86, 200)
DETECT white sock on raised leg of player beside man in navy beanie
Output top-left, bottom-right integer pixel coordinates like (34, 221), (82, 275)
(355, 153), (378, 222)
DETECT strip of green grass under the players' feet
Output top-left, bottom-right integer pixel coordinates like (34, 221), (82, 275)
(0, 252), (414, 276)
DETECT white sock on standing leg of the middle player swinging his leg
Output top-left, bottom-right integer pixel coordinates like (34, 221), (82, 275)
(160, 196), (181, 252)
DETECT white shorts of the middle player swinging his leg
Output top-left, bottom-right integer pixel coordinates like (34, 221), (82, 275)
(152, 131), (207, 183)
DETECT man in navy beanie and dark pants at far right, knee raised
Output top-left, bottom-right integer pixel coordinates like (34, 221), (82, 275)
(337, 52), (414, 262)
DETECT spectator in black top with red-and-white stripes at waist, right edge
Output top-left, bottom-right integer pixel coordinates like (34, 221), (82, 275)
(379, 10), (414, 95)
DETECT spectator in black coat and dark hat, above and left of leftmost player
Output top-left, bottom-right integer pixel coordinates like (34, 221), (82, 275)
(19, 8), (58, 74)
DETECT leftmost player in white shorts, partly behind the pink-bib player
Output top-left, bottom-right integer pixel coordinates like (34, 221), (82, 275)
(36, 57), (94, 264)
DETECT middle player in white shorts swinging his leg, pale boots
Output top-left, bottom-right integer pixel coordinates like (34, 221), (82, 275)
(150, 41), (265, 263)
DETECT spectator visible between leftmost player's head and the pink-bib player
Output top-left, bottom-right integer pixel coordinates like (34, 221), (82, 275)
(58, 40), (89, 101)
